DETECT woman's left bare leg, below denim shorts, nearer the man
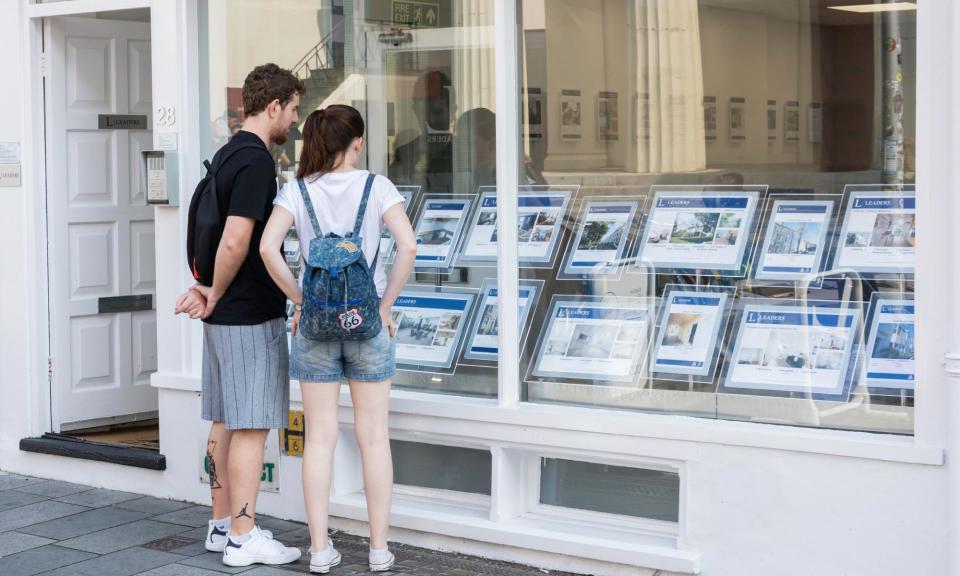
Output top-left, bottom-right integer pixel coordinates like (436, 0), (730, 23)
(300, 382), (340, 552)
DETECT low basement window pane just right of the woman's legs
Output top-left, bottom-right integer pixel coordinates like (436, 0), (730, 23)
(390, 440), (492, 496)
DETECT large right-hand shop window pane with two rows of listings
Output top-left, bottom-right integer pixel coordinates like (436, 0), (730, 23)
(518, 0), (916, 434)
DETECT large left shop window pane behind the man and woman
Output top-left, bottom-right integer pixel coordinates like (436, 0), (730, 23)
(200, 0), (497, 397)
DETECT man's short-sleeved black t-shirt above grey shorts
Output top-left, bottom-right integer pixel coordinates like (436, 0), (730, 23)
(206, 130), (286, 326)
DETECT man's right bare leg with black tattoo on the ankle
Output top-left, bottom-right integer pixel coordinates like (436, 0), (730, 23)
(227, 430), (269, 536)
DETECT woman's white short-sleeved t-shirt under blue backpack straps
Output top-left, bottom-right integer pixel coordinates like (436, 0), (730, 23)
(273, 170), (403, 296)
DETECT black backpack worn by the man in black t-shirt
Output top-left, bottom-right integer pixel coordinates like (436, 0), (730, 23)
(187, 143), (273, 286)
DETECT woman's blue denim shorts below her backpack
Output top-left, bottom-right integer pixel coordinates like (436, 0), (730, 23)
(290, 327), (397, 382)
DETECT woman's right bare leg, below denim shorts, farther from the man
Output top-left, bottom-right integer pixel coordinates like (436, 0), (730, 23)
(350, 380), (393, 549)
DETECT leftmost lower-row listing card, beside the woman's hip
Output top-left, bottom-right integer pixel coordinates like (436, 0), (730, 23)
(392, 290), (475, 368)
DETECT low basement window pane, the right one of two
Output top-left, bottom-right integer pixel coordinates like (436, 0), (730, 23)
(540, 458), (680, 522)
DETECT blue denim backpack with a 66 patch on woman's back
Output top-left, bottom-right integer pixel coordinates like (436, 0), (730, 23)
(297, 173), (382, 342)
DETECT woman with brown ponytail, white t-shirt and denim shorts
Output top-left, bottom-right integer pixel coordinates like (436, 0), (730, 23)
(260, 105), (417, 574)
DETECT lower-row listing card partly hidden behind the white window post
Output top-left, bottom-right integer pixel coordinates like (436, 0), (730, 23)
(463, 278), (543, 361)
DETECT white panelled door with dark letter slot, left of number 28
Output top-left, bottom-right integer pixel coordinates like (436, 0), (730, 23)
(46, 18), (157, 431)
